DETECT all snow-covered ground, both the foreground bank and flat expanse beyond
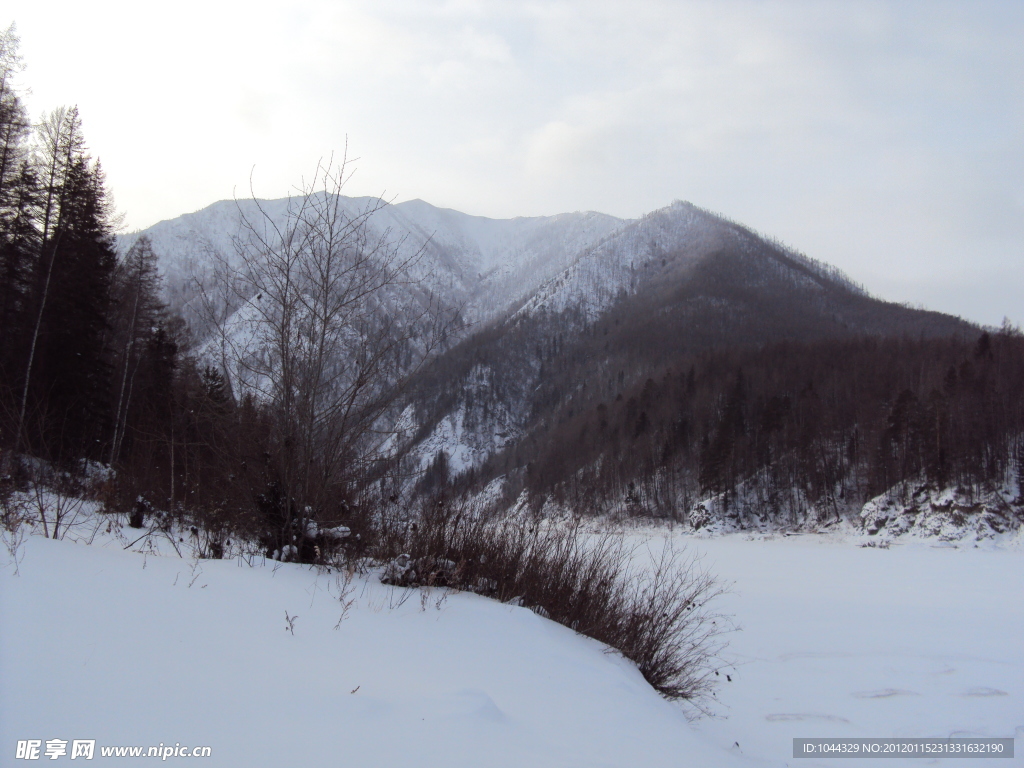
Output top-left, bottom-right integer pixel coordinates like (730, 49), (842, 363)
(0, 518), (1024, 768)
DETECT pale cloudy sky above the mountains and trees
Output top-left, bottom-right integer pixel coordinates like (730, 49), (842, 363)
(9, 0), (1024, 325)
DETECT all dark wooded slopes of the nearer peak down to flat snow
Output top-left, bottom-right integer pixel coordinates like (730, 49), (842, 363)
(405, 243), (1024, 524)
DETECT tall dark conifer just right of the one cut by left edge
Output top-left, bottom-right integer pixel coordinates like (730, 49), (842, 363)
(15, 108), (116, 459)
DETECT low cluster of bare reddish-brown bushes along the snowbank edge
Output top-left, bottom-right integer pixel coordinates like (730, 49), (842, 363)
(378, 504), (729, 709)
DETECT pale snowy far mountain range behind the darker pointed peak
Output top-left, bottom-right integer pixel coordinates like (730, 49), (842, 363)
(122, 198), (627, 331)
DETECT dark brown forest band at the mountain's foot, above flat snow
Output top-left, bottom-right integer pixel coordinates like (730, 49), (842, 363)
(461, 328), (1024, 523)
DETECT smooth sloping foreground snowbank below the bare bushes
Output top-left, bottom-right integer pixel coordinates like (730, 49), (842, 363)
(0, 537), (743, 767)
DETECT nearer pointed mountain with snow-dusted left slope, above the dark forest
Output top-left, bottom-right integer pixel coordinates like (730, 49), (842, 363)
(387, 202), (968, 493)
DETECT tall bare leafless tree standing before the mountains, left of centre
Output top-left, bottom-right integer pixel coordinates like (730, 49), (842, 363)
(199, 153), (456, 559)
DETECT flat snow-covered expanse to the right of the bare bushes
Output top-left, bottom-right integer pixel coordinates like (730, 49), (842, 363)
(652, 535), (1024, 768)
